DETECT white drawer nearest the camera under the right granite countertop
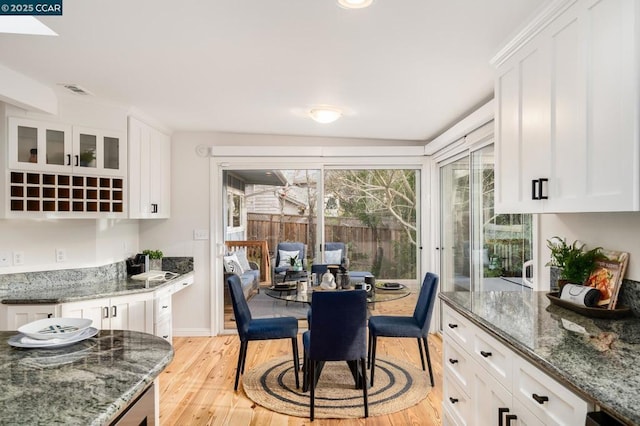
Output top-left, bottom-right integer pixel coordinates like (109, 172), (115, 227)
(512, 357), (590, 425)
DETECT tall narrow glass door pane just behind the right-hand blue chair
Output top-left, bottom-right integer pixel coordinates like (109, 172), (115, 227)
(439, 157), (471, 291)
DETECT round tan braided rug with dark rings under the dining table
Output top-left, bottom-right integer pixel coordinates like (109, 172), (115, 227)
(242, 357), (431, 419)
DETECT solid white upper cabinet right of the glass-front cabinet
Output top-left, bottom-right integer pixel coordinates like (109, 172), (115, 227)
(129, 117), (171, 219)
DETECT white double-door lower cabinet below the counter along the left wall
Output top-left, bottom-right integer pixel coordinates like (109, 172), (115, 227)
(60, 293), (153, 333)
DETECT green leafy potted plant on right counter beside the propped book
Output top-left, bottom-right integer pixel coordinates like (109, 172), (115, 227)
(546, 237), (605, 290)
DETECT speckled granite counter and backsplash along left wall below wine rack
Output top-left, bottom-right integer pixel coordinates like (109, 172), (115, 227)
(0, 258), (193, 305)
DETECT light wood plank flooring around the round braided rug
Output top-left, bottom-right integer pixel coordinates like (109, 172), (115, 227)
(159, 332), (442, 426)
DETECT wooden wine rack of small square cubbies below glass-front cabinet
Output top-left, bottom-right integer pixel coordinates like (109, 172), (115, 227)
(9, 171), (125, 217)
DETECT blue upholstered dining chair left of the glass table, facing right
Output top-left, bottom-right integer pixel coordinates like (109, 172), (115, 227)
(227, 274), (300, 390)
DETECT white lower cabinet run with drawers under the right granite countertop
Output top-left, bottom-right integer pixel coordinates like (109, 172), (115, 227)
(442, 305), (593, 426)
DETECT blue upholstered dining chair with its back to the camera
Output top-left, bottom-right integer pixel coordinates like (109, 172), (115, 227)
(302, 290), (369, 420)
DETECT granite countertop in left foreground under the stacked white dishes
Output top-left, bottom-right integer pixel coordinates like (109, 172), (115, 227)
(0, 330), (173, 425)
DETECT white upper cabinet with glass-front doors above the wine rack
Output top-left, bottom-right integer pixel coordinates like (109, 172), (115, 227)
(9, 117), (127, 176)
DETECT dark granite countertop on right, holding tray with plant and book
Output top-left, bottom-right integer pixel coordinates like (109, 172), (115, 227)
(440, 291), (640, 424)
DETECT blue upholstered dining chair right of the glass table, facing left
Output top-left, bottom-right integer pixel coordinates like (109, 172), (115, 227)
(369, 272), (438, 386)
